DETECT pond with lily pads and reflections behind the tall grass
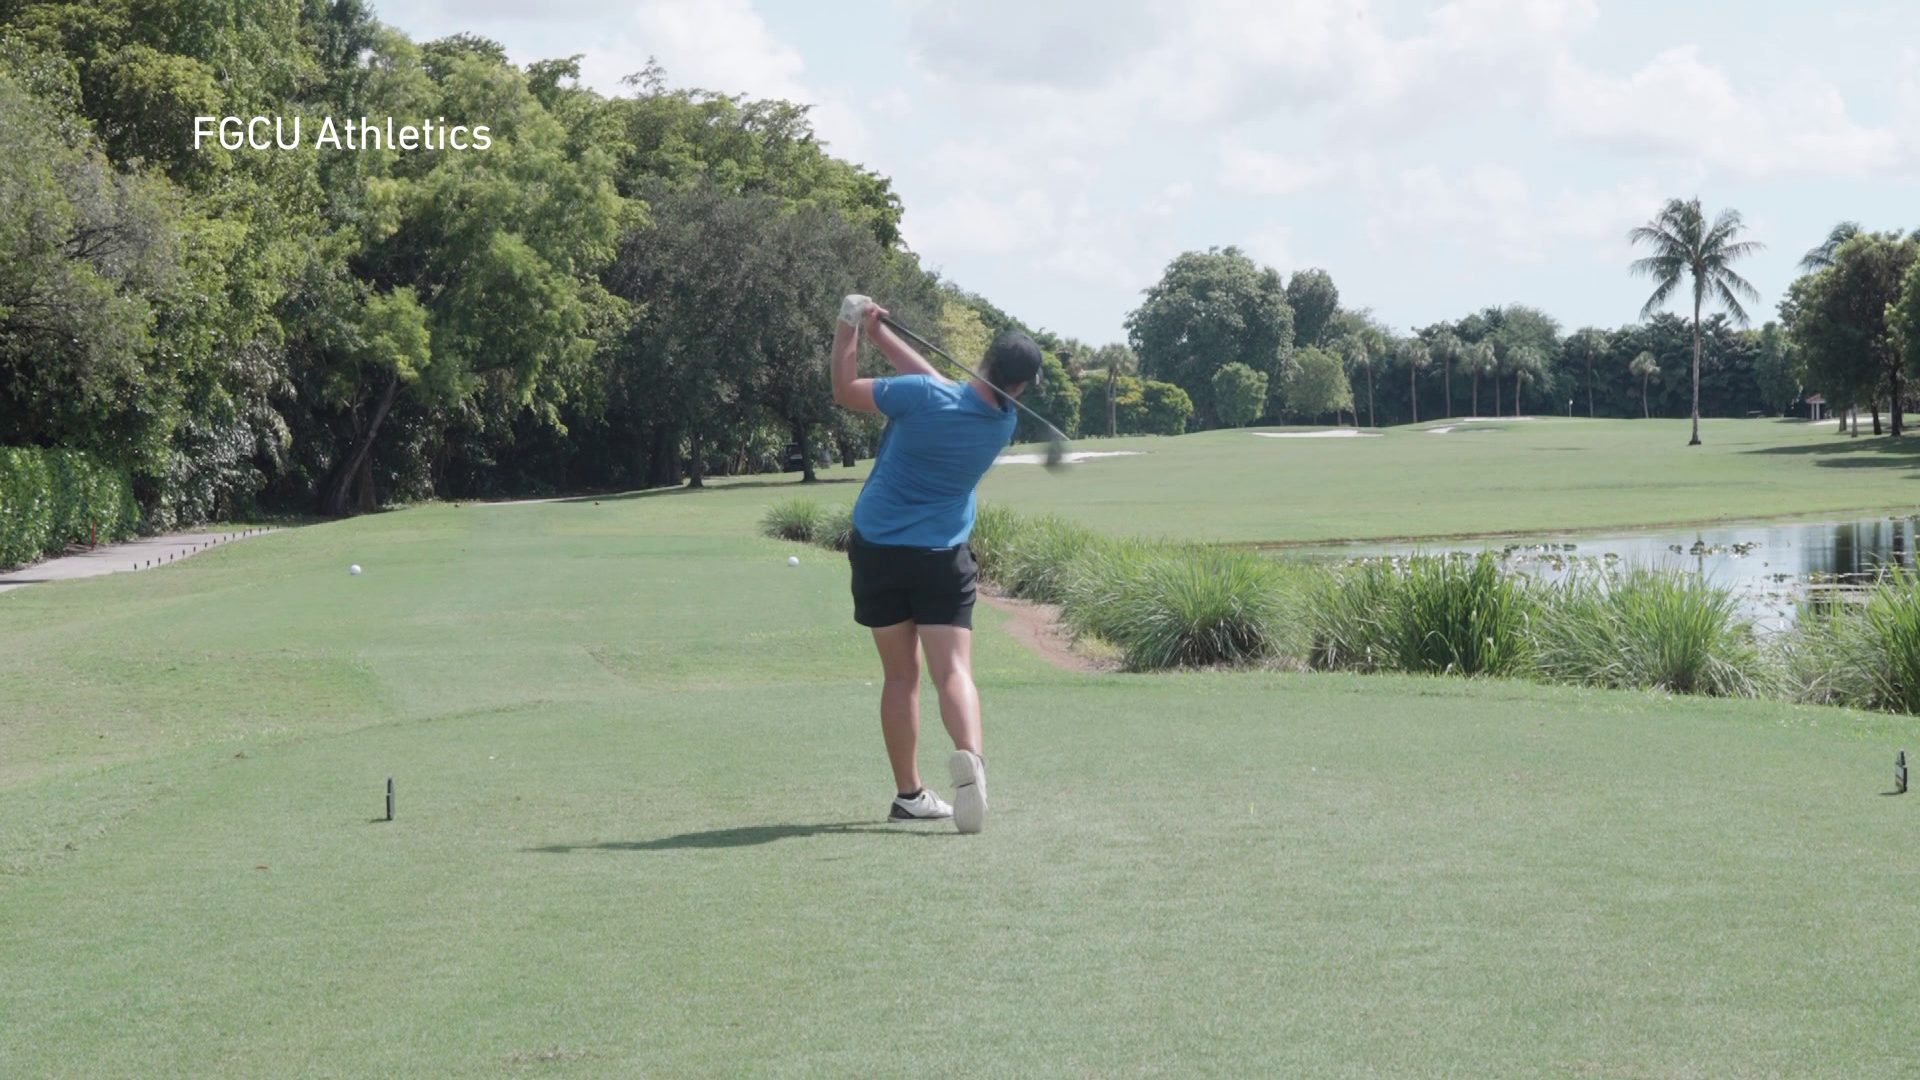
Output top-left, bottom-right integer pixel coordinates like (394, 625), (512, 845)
(1313, 517), (1920, 630)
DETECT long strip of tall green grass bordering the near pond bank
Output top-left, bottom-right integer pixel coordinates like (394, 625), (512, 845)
(762, 500), (1920, 715)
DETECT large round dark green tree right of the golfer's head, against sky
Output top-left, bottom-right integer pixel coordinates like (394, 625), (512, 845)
(1127, 248), (1294, 427)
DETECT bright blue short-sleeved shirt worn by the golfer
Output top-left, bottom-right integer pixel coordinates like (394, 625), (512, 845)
(852, 375), (1020, 548)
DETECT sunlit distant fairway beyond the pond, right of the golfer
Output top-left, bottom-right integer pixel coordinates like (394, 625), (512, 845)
(981, 417), (1920, 544)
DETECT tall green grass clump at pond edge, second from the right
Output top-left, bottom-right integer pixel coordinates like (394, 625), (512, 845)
(1532, 567), (1774, 698)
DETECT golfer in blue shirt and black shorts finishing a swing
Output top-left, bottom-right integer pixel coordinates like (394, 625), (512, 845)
(833, 296), (1041, 832)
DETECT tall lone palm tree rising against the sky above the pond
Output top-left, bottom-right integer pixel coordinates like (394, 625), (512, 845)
(1626, 198), (1763, 446)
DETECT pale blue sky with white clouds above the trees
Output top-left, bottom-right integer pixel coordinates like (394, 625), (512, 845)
(372, 0), (1920, 344)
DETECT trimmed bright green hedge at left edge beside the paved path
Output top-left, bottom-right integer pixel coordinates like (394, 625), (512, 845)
(0, 446), (140, 567)
